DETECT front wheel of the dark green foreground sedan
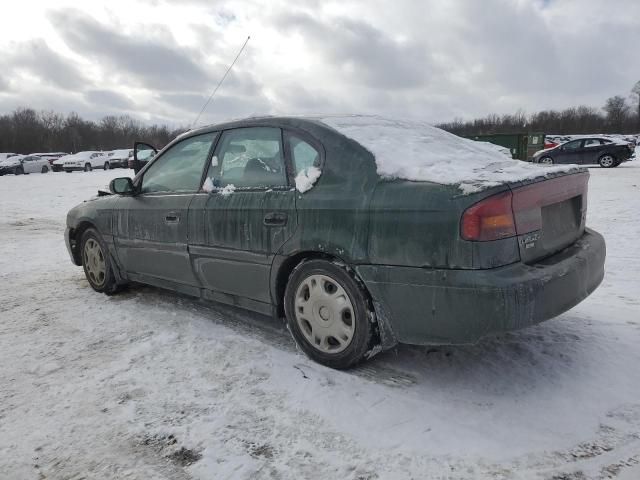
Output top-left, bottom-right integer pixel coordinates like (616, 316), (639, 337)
(80, 228), (118, 295)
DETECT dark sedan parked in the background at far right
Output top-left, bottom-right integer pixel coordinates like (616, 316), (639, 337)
(533, 137), (635, 168)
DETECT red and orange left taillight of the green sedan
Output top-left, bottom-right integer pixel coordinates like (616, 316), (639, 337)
(460, 191), (516, 242)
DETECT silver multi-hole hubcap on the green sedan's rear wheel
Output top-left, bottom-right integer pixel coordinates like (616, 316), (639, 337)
(295, 275), (355, 353)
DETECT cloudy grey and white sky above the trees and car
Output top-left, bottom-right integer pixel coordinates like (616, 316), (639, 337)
(0, 0), (640, 126)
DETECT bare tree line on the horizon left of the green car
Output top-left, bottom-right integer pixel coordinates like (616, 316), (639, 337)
(0, 108), (186, 154)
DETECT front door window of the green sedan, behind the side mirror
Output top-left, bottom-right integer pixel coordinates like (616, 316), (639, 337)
(141, 132), (217, 193)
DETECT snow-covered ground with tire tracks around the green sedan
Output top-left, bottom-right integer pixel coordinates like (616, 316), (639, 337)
(0, 166), (640, 480)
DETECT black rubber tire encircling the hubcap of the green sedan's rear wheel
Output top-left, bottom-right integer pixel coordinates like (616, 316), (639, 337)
(284, 260), (375, 370)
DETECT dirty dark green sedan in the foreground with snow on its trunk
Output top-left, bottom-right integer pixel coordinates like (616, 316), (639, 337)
(65, 117), (605, 368)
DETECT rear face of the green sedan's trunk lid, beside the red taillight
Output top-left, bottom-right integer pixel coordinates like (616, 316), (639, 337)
(510, 172), (589, 263)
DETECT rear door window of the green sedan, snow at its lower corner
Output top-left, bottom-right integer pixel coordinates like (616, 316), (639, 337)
(207, 127), (287, 188)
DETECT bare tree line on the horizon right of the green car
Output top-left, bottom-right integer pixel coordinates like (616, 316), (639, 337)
(438, 81), (640, 136)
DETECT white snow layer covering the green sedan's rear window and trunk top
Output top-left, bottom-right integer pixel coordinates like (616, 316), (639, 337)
(313, 115), (580, 194)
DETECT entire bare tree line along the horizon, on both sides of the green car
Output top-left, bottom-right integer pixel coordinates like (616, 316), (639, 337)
(0, 81), (640, 153)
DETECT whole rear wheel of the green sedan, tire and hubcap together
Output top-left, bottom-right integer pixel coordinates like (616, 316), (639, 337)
(285, 260), (375, 369)
